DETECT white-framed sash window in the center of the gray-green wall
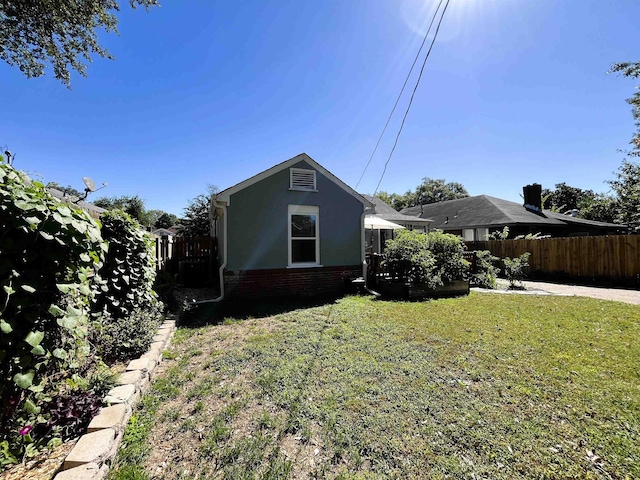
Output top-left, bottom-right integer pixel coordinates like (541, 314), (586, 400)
(289, 205), (320, 267)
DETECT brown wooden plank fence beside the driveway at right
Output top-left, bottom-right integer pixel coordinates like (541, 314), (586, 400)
(467, 235), (640, 285)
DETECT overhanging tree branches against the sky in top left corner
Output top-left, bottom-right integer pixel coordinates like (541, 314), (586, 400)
(0, 0), (158, 87)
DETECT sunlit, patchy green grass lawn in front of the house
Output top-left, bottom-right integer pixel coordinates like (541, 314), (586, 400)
(110, 293), (640, 479)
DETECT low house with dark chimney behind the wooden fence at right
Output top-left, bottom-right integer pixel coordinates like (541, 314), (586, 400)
(401, 185), (626, 241)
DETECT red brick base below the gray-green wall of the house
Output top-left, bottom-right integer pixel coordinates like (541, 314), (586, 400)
(224, 265), (362, 298)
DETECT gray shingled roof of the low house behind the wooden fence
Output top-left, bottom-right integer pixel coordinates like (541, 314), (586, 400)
(400, 195), (566, 230)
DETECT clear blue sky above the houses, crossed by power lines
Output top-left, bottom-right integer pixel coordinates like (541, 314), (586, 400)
(0, 0), (640, 215)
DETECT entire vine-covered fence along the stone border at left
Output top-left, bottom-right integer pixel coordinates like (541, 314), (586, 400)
(0, 157), (160, 468)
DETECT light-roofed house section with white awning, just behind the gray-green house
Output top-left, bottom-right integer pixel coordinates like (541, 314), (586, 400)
(362, 195), (431, 253)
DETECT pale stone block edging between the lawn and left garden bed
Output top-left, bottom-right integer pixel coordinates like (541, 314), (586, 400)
(53, 315), (176, 480)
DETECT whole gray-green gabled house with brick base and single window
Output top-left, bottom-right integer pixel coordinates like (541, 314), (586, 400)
(211, 153), (371, 298)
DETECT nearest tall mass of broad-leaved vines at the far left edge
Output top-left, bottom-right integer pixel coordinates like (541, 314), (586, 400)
(0, 163), (107, 465)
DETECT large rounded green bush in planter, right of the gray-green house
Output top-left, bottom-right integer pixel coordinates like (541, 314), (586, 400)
(384, 230), (469, 288)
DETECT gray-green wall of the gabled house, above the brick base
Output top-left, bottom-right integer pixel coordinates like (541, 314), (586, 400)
(227, 162), (364, 270)
